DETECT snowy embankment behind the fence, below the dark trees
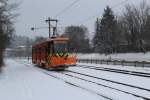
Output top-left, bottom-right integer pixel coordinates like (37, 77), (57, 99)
(77, 52), (150, 62)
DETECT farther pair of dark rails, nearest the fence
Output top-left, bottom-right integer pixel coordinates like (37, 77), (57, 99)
(74, 65), (150, 78)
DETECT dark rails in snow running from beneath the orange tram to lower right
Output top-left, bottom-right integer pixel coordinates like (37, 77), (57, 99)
(15, 59), (150, 100)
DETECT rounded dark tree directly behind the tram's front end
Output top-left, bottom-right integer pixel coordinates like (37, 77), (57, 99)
(62, 26), (90, 53)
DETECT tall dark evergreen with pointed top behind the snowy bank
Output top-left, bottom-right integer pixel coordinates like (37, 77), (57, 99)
(93, 6), (118, 53)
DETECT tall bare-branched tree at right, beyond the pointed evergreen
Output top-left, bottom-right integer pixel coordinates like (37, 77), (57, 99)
(121, 1), (150, 51)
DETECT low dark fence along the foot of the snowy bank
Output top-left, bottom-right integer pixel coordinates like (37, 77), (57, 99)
(77, 59), (150, 67)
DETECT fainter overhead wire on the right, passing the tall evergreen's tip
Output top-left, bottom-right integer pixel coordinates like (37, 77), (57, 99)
(79, 0), (128, 24)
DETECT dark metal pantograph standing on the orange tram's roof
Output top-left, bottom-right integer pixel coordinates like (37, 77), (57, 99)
(45, 17), (58, 38)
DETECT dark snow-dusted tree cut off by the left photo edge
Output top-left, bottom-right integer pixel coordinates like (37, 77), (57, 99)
(0, 0), (18, 67)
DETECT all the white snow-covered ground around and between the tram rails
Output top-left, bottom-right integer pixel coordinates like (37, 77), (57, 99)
(0, 59), (150, 100)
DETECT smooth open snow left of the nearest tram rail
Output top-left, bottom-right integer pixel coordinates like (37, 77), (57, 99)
(0, 59), (103, 100)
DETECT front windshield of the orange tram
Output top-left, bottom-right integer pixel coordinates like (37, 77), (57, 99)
(54, 42), (68, 53)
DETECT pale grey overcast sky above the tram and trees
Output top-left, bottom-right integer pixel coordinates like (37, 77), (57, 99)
(12, 0), (150, 38)
